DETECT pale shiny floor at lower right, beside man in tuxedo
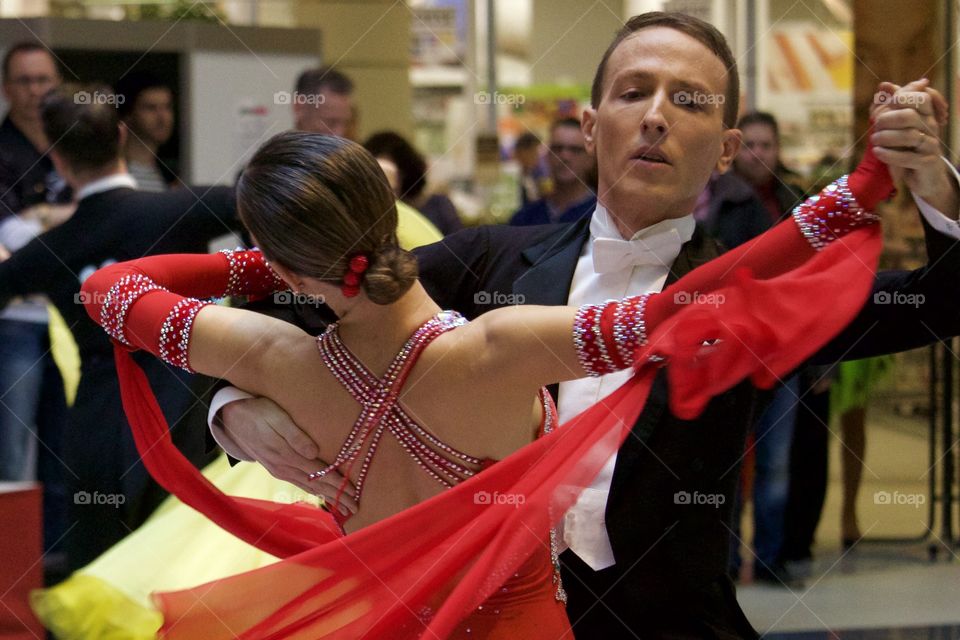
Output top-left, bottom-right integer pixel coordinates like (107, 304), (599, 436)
(737, 412), (960, 640)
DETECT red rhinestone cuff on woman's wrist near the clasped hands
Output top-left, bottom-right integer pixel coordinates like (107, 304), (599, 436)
(792, 176), (880, 251)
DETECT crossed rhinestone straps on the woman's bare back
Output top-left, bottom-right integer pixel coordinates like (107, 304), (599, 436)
(310, 311), (493, 513)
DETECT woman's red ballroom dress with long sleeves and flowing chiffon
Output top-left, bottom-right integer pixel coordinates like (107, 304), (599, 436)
(83, 151), (891, 640)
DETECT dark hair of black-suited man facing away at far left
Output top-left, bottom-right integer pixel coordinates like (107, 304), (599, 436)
(40, 83), (120, 171)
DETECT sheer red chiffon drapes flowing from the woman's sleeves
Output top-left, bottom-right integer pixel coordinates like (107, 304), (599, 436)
(99, 220), (880, 640)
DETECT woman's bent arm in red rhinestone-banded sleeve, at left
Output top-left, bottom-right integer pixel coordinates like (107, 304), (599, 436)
(82, 251), (306, 393)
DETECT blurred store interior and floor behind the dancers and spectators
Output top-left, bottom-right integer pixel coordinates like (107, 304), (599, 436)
(0, 0), (960, 638)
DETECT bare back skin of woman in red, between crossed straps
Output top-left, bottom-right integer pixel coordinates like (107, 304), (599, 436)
(258, 310), (543, 531)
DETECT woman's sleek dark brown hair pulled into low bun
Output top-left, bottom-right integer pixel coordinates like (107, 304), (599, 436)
(237, 131), (417, 304)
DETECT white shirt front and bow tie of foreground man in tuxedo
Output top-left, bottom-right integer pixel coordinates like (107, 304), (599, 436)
(557, 204), (696, 571)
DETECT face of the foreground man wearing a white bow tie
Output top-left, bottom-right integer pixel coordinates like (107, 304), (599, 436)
(583, 27), (739, 219)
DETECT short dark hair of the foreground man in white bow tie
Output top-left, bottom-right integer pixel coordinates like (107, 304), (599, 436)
(590, 11), (740, 128)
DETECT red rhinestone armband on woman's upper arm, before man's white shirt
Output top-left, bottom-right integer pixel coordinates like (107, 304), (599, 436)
(573, 293), (653, 377)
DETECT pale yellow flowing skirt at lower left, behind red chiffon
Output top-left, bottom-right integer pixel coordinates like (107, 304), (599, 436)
(30, 455), (319, 640)
